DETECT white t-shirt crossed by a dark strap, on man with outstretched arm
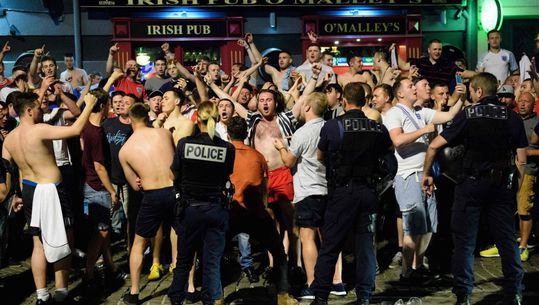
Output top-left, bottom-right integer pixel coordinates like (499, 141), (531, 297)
(384, 103), (436, 178)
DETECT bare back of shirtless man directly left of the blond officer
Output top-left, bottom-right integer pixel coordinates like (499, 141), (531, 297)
(120, 127), (174, 190)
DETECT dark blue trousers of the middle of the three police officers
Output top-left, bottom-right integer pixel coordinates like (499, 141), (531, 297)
(312, 183), (378, 300)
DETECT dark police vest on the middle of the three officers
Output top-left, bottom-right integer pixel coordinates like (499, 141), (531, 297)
(328, 111), (383, 184)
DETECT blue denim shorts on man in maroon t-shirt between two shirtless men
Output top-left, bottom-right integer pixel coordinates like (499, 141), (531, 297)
(84, 183), (112, 231)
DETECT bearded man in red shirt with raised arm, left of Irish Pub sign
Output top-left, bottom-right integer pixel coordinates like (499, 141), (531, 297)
(106, 44), (148, 100)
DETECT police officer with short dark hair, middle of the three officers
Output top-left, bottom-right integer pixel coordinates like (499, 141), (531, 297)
(311, 83), (391, 305)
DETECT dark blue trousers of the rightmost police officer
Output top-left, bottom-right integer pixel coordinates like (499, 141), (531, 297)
(451, 178), (524, 296)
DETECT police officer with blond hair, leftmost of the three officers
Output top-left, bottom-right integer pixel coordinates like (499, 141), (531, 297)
(168, 102), (235, 305)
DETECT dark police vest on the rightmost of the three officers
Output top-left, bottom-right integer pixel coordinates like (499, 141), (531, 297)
(463, 101), (512, 172)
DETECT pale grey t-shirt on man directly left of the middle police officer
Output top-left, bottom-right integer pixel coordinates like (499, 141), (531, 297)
(290, 118), (328, 203)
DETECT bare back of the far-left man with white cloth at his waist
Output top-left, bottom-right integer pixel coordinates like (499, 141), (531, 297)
(2, 124), (62, 183)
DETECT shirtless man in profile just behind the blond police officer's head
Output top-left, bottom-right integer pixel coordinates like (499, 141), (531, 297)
(153, 90), (195, 145)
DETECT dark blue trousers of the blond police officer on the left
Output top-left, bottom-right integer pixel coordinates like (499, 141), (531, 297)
(168, 202), (228, 305)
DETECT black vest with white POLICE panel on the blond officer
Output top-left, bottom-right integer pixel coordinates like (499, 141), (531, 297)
(178, 133), (234, 200)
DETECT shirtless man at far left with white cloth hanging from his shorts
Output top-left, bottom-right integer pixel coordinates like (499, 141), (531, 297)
(2, 89), (96, 304)
